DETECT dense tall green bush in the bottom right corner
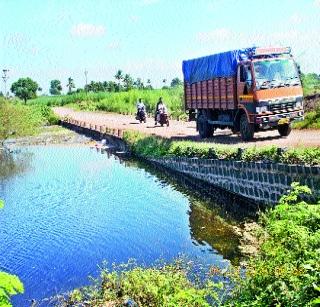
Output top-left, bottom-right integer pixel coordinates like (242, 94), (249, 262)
(230, 183), (320, 306)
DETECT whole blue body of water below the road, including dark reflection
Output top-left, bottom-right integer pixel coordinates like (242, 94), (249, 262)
(0, 146), (255, 306)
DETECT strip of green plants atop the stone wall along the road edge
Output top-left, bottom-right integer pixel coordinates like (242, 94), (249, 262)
(124, 131), (320, 165)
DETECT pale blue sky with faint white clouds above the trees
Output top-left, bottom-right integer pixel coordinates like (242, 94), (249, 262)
(0, 0), (320, 94)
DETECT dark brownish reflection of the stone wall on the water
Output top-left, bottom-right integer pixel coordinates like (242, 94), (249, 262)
(102, 151), (260, 264)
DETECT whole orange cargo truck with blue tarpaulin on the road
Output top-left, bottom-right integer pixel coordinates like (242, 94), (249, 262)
(182, 47), (304, 141)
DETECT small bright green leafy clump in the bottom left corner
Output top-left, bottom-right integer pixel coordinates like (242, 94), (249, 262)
(0, 272), (24, 307)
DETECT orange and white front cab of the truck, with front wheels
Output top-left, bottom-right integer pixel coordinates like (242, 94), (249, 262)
(235, 48), (304, 140)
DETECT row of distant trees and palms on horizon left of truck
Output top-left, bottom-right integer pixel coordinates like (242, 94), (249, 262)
(0, 69), (183, 103)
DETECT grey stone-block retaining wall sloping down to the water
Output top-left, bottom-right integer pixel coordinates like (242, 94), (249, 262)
(151, 157), (320, 204)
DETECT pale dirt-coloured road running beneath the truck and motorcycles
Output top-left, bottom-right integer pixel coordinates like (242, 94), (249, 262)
(54, 107), (320, 147)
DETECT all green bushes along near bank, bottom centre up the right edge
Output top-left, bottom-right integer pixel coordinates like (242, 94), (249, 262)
(58, 183), (320, 307)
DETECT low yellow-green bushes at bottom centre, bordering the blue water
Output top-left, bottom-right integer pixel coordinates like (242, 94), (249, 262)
(68, 260), (222, 307)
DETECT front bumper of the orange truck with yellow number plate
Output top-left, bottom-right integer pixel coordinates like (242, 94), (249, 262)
(255, 111), (304, 129)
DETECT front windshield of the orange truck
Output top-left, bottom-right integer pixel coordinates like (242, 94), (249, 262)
(253, 59), (301, 90)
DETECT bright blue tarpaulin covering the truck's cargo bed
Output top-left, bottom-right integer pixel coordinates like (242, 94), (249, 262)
(182, 48), (251, 83)
